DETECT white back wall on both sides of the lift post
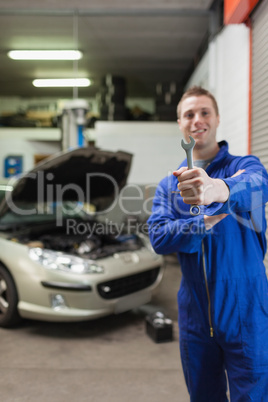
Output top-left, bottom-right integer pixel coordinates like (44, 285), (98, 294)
(0, 121), (185, 185)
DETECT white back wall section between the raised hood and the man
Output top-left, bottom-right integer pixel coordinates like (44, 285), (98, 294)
(90, 121), (185, 184)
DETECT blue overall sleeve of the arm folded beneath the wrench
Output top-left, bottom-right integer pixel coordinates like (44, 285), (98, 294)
(148, 180), (208, 254)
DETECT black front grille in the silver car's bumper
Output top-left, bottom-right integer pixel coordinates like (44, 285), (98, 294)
(97, 267), (160, 299)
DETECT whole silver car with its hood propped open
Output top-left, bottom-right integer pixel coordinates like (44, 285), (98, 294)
(0, 147), (163, 327)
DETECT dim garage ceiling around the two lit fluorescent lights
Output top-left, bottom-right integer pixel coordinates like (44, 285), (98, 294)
(0, 0), (220, 97)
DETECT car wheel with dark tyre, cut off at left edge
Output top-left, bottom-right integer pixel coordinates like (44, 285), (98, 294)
(0, 264), (21, 328)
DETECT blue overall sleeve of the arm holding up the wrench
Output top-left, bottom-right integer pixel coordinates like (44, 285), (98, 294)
(204, 156), (268, 215)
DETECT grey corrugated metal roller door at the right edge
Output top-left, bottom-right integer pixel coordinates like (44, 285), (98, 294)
(251, 0), (268, 270)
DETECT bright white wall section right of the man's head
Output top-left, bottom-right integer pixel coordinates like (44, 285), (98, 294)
(186, 24), (249, 155)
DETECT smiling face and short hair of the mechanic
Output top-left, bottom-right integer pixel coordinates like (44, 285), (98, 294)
(178, 95), (219, 149)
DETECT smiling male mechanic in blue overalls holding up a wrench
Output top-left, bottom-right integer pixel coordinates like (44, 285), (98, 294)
(148, 87), (268, 402)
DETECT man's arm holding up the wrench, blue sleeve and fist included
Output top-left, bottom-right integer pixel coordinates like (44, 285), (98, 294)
(173, 155), (268, 216)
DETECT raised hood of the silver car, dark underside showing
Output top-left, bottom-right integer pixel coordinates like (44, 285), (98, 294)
(0, 147), (132, 216)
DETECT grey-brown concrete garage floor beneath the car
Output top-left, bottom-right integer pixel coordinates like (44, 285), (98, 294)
(0, 257), (189, 402)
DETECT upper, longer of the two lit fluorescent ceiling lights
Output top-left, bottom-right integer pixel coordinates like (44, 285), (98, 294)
(8, 50), (83, 60)
